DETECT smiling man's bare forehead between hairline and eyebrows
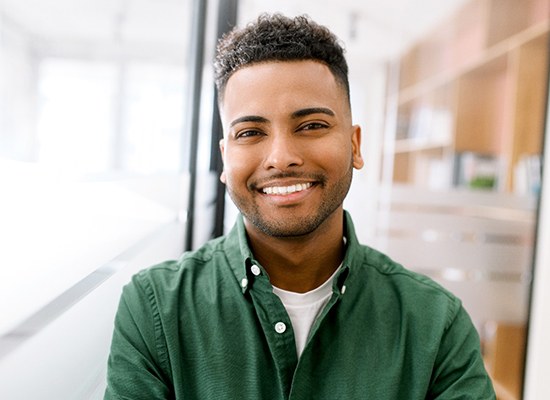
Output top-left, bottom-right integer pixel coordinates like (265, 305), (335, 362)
(220, 60), (349, 120)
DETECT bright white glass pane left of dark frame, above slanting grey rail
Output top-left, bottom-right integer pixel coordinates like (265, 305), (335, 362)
(0, 0), (191, 334)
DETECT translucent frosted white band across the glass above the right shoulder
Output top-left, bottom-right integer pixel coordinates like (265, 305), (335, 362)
(374, 185), (536, 337)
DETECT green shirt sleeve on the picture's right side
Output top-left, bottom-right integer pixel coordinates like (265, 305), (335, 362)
(429, 306), (496, 400)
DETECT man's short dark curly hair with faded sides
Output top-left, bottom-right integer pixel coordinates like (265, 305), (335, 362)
(214, 13), (350, 101)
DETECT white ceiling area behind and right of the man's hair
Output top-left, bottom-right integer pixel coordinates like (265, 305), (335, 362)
(240, 0), (466, 62)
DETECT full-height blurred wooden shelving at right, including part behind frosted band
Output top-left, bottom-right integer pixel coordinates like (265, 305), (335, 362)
(374, 0), (550, 399)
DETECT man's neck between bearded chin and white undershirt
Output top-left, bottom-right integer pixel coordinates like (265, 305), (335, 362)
(245, 210), (344, 293)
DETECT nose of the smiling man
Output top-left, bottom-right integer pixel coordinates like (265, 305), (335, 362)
(264, 133), (304, 171)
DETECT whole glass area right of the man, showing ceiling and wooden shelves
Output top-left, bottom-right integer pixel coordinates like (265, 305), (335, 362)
(236, 0), (550, 398)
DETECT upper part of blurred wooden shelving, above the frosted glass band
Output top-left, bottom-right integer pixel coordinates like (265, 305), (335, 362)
(386, 0), (550, 191)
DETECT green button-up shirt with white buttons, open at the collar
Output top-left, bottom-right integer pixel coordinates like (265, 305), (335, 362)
(105, 213), (495, 400)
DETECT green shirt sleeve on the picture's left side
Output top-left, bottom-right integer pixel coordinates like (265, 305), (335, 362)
(104, 275), (171, 400)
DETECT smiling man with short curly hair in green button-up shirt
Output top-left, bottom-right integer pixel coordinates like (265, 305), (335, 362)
(105, 15), (495, 400)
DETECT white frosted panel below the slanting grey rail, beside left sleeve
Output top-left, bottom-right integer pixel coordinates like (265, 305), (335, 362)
(0, 223), (183, 400)
